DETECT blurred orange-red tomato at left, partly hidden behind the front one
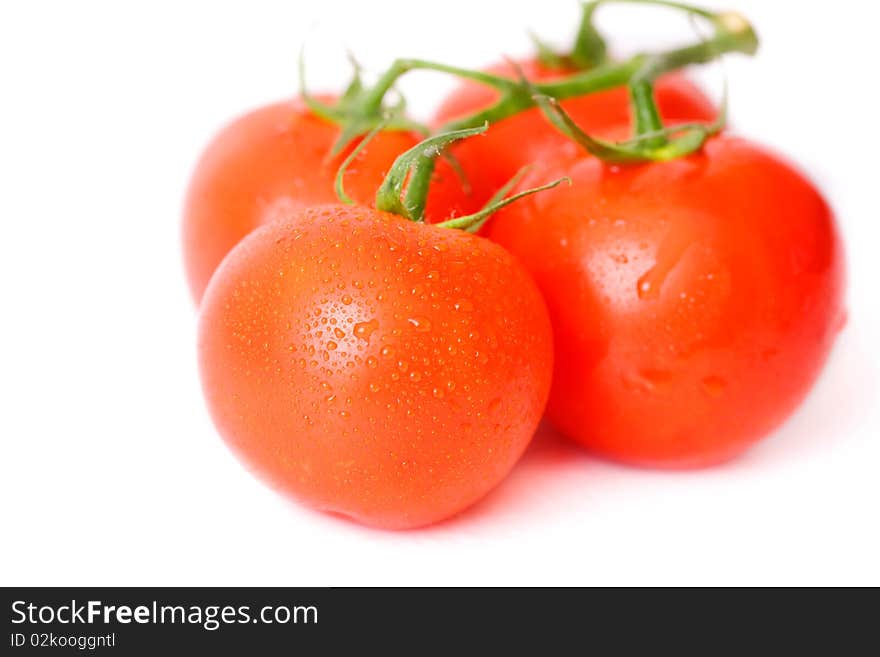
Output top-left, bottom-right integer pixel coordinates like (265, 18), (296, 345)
(183, 100), (469, 302)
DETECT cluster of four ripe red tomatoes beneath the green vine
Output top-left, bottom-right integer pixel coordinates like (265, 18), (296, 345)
(183, 2), (844, 528)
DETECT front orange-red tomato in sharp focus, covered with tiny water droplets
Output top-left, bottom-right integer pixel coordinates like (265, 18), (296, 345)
(199, 205), (552, 528)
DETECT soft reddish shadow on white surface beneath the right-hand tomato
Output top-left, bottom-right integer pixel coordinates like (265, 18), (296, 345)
(428, 322), (880, 533)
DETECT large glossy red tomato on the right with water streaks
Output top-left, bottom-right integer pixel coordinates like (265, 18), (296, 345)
(487, 135), (844, 466)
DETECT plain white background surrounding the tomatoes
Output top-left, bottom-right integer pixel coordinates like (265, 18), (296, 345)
(0, 0), (880, 585)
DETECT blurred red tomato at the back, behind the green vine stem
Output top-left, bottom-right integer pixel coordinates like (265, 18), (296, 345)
(434, 60), (717, 211)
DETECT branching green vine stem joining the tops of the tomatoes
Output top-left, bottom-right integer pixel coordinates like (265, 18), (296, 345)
(316, 0), (758, 221)
